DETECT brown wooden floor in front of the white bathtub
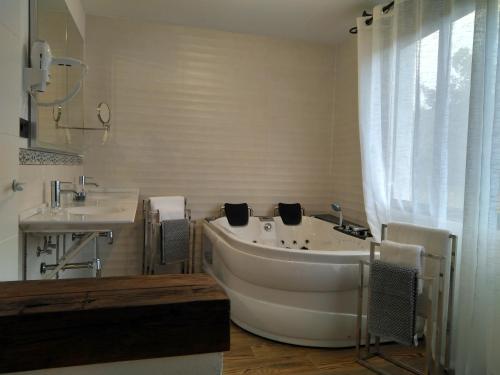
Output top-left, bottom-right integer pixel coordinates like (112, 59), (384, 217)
(224, 324), (423, 375)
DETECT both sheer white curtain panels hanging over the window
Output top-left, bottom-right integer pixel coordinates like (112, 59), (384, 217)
(357, 0), (500, 375)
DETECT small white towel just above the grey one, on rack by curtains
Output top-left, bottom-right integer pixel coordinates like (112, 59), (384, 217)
(380, 240), (424, 294)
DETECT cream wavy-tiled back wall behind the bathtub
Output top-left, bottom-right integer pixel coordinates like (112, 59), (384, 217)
(84, 17), (335, 274)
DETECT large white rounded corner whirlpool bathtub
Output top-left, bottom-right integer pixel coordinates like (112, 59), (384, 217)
(202, 216), (370, 347)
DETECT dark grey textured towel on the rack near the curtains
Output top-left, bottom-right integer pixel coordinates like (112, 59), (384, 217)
(368, 260), (418, 345)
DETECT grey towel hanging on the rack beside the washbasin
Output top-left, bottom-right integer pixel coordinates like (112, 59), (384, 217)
(160, 219), (189, 264)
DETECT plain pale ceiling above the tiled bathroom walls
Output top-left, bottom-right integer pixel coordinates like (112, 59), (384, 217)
(81, 0), (380, 44)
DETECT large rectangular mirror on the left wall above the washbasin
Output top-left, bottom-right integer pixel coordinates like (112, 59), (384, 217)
(30, 0), (84, 153)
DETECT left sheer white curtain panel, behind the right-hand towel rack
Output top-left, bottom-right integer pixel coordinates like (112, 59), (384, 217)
(357, 0), (474, 239)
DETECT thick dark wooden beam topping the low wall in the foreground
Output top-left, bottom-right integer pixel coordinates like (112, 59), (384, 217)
(0, 274), (229, 372)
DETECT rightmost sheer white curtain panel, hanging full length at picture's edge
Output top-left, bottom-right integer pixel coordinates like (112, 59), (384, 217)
(455, 0), (500, 375)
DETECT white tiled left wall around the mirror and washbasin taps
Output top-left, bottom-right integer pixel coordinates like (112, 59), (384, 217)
(0, 0), (82, 281)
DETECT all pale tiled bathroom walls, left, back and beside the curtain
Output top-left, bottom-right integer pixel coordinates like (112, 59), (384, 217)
(0, 0), (366, 279)
